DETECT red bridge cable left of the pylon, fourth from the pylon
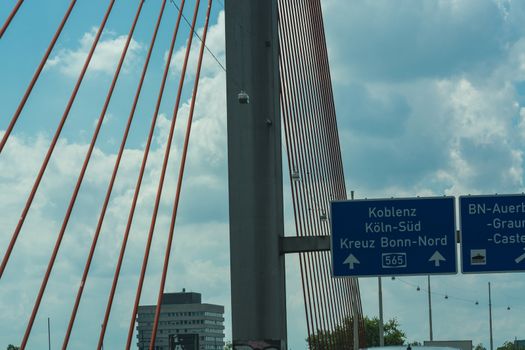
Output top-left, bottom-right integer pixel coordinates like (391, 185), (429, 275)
(62, 0), (166, 350)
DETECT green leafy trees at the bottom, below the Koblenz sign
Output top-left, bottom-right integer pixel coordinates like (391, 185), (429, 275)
(306, 316), (406, 350)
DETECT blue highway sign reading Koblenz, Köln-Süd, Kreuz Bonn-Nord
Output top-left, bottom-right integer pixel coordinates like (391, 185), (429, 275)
(331, 197), (457, 277)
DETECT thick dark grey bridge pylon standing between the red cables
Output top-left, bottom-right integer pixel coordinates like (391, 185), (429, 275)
(225, 0), (287, 349)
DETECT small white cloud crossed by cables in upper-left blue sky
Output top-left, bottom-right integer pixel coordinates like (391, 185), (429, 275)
(46, 27), (143, 77)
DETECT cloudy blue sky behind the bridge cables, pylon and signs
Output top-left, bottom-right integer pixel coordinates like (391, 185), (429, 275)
(0, 0), (525, 349)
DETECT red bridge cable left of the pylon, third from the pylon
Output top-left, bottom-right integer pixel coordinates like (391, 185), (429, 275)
(97, 0), (185, 350)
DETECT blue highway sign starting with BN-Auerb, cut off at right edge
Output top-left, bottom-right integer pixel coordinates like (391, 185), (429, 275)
(459, 195), (525, 273)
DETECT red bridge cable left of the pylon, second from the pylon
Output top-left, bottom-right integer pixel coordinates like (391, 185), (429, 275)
(126, 0), (200, 350)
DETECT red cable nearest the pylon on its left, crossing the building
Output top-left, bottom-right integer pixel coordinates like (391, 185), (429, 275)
(149, 0), (212, 350)
